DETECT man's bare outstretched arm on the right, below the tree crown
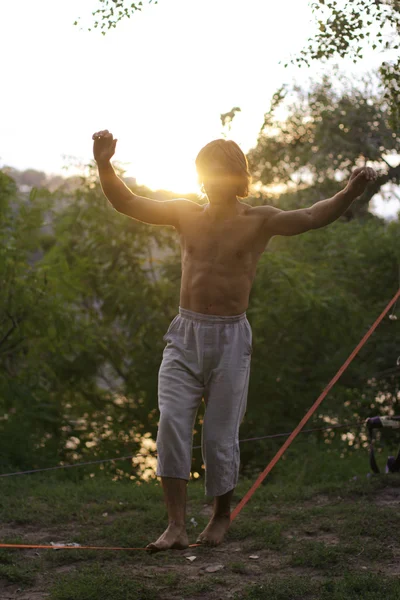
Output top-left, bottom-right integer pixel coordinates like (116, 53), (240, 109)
(256, 167), (377, 236)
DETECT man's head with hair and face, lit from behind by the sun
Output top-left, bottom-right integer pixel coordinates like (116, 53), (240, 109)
(196, 139), (251, 198)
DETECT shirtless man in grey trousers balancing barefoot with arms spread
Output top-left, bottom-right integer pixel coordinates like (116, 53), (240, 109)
(93, 130), (376, 551)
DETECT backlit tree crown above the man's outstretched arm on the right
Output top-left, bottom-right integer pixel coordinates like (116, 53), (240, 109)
(248, 74), (400, 218)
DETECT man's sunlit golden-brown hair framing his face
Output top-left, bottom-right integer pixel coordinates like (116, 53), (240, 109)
(196, 139), (251, 198)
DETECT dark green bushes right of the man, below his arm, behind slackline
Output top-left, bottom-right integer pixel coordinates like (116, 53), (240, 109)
(240, 219), (400, 472)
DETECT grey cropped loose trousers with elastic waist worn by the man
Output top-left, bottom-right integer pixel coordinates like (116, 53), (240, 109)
(156, 307), (252, 496)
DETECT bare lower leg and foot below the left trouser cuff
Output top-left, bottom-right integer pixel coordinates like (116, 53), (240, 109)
(146, 477), (189, 552)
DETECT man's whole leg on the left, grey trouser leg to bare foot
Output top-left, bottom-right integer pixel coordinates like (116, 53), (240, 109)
(147, 317), (204, 551)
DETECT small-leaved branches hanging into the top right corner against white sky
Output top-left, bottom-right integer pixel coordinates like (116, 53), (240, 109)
(285, 0), (400, 129)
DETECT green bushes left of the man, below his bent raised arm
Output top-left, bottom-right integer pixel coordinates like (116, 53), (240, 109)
(0, 164), (179, 478)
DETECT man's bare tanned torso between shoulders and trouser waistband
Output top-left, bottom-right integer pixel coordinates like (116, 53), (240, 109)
(178, 202), (270, 316)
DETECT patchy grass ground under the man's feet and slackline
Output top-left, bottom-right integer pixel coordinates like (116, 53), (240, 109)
(0, 448), (400, 600)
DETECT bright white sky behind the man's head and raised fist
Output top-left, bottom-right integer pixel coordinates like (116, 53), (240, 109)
(0, 0), (400, 216)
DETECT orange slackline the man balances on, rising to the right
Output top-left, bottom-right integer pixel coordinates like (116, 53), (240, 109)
(0, 289), (400, 550)
